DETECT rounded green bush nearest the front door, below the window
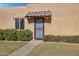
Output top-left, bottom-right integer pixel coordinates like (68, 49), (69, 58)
(17, 30), (32, 41)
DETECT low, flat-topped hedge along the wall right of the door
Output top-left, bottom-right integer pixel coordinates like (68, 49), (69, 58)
(44, 35), (79, 43)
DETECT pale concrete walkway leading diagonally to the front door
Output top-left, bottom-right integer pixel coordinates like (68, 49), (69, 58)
(8, 40), (43, 56)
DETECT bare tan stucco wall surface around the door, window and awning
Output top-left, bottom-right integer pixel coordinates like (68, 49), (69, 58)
(0, 4), (79, 35)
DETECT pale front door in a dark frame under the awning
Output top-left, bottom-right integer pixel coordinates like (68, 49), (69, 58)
(34, 18), (44, 39)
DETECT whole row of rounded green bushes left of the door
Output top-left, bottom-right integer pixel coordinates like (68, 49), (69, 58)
(0, 29), (32, 41)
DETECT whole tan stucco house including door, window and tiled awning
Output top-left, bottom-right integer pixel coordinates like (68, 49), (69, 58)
(0, 3), (79, 38)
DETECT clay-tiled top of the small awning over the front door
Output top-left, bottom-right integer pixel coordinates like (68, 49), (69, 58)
(26, 10), (52, 17)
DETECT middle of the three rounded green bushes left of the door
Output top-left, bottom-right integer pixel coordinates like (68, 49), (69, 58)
(3, 29), (17, 41)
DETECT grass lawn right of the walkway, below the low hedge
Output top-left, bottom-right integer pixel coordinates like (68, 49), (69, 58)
(28, 42), (79, 56)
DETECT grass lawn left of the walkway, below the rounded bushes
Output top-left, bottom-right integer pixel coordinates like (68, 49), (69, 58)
(0, 41), (28, 56)
